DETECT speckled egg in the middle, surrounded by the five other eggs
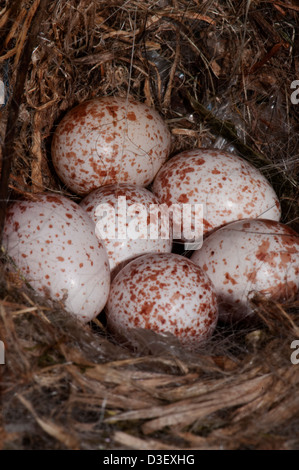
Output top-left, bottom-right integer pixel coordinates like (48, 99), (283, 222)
(80, 183), (172, 270)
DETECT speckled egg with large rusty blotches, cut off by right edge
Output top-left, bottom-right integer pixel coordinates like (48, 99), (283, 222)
(191, 219), (299, 321)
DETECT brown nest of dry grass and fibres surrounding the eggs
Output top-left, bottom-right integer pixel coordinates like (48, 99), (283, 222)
(0, 0), (299, 450)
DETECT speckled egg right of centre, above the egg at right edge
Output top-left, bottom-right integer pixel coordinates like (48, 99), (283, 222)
(152, 149), (281, 240)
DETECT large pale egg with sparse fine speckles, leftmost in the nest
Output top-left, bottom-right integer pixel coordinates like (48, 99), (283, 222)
(3, 194), (110, 322)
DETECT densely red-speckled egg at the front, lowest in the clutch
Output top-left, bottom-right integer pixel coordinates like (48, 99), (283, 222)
(105, 253), (218, 349)
